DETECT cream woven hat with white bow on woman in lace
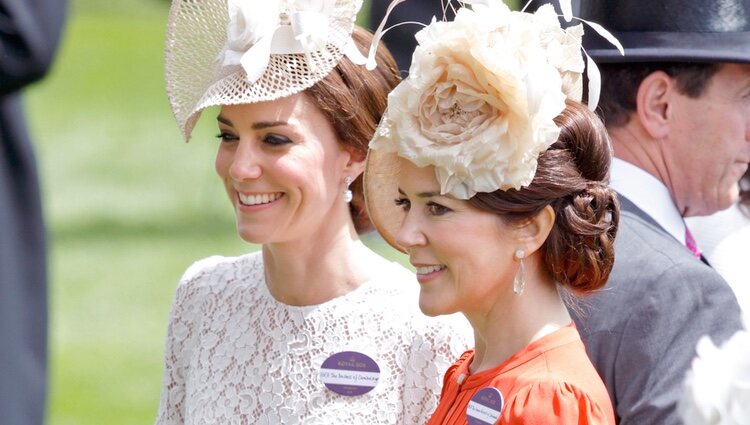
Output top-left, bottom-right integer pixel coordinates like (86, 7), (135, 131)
(165, 0), (374, 140)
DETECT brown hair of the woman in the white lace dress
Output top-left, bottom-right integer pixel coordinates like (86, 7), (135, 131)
(305, 26), (400, 233)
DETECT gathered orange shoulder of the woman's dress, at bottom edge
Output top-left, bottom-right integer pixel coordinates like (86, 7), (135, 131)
(502, 381), (615, 425)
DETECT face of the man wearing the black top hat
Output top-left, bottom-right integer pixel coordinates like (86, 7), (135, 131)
(664, 64), (750, 217)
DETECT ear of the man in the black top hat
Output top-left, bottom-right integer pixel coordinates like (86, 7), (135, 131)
(636, 71), (677, 140)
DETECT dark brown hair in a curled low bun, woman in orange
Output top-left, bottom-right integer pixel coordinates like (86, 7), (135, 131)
(469, 101), (620, 293)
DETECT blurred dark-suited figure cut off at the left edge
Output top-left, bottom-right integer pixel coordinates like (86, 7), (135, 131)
(0, 0), (65, 425)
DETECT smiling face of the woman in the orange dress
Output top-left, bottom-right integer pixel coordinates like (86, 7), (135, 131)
(395, 159), (518, 316)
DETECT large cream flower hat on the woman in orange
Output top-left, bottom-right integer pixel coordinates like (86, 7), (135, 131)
(365, 0), (619, 248)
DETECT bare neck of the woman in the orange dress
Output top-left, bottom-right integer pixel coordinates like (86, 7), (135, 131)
(465, 264), (571, 374)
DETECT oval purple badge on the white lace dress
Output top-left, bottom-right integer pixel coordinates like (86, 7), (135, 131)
(320, 351), (380, 396)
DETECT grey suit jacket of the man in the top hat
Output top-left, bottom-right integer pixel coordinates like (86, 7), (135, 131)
(572, 202), (741, 425)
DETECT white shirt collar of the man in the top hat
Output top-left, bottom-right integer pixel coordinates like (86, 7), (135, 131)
(610, 158), (685, 245)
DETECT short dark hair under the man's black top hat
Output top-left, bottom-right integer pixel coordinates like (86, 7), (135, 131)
(599, 62), (721, 128)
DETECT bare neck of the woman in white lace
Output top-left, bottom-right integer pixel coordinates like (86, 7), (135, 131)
(263, 221), (384, 306)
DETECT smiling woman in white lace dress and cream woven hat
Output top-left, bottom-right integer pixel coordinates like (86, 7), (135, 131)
(156, 0), (470, 425)
